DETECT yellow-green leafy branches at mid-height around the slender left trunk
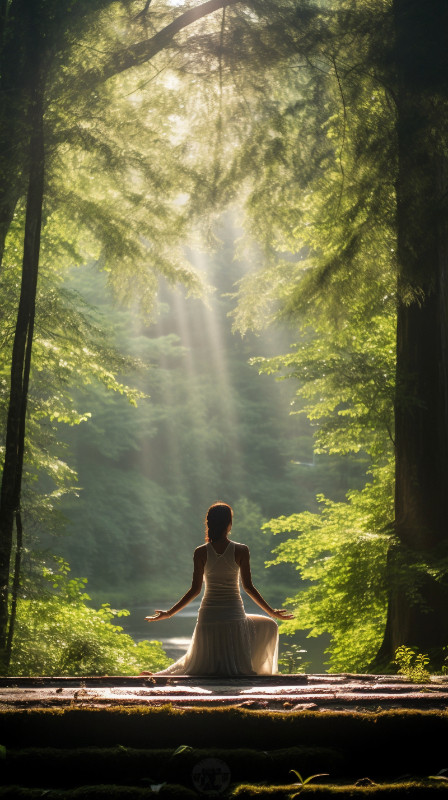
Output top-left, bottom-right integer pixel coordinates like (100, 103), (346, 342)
(0, 209), (150, 545)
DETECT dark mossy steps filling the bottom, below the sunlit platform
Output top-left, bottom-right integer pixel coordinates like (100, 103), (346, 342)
(0, 706), (448, 800)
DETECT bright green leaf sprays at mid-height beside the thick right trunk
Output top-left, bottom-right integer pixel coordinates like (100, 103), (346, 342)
(252, 310), (395, 463)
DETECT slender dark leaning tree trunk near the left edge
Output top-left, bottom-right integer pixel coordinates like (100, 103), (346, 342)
(0, 84), (44, 671)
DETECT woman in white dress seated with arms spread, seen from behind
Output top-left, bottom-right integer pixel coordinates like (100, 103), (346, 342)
(142, 503), (293, 675)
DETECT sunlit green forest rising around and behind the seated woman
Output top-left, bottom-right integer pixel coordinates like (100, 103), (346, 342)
(0, 0), (448, 675)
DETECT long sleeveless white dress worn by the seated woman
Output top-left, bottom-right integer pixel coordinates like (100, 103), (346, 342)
(155, 542), (278, 676)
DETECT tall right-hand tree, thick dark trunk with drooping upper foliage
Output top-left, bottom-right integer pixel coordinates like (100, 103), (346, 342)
(226, 0), (448, 668)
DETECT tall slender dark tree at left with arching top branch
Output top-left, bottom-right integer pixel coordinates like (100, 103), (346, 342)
(0, 0), (242, 669)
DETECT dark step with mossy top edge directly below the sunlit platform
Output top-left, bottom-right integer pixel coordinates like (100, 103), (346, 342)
(0, 706), (448, 752)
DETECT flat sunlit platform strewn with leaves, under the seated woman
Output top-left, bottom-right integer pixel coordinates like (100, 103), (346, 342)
(0, 674), (448, 713)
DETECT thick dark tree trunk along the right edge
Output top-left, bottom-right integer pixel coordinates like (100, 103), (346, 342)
(375, 0), (448, 666)
